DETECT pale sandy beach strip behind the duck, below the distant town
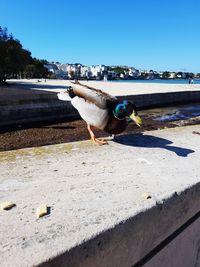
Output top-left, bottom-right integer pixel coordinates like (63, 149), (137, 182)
(9, 79), (200, 96)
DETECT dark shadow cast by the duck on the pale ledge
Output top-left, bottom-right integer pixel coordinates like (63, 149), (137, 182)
(114, 133), (195, 157)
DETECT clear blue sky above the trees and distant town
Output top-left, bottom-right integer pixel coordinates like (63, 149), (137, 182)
(0, 0), (200, 73)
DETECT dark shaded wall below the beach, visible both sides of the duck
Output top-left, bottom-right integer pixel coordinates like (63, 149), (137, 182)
(0, 87), (200, 127)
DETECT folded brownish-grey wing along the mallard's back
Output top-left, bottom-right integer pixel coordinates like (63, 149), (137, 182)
(71, 82), (118, 109)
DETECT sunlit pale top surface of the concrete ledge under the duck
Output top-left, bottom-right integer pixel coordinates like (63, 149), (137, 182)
(0, 125), (200, 267)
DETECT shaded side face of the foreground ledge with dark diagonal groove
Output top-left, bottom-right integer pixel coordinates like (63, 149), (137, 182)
(41, 184), (200, 267)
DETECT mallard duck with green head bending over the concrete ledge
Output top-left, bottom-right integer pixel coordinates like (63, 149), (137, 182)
(58, 81), (142, 145)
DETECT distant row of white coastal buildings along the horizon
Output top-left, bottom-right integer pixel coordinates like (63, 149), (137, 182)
(44, 62), (200, 81)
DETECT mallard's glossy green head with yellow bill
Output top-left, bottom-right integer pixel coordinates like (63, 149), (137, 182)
(113, 100), (142, 126)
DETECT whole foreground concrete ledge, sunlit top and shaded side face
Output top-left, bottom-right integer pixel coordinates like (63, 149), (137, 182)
(0, 125), (200, 267)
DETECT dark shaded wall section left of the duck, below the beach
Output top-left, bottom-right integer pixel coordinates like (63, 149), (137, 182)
(0, 88), (79, 127)
